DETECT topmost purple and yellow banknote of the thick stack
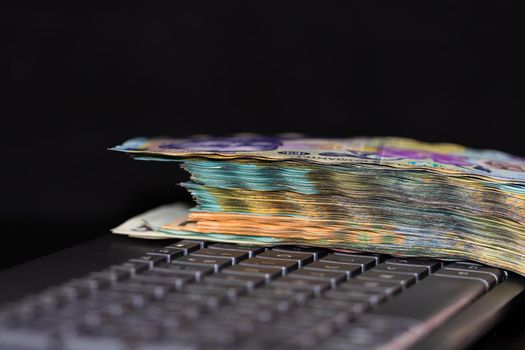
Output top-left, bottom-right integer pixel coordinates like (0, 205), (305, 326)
(112, 136), (525, 181)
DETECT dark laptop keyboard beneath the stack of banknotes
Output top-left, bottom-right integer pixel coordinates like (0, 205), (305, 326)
(0, 240), (506, 350)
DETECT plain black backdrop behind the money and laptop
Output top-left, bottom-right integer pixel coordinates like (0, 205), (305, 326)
(4, 1), (525, 265)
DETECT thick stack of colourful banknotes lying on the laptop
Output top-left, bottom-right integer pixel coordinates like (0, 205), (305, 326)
(113, 135), (525, 275)
